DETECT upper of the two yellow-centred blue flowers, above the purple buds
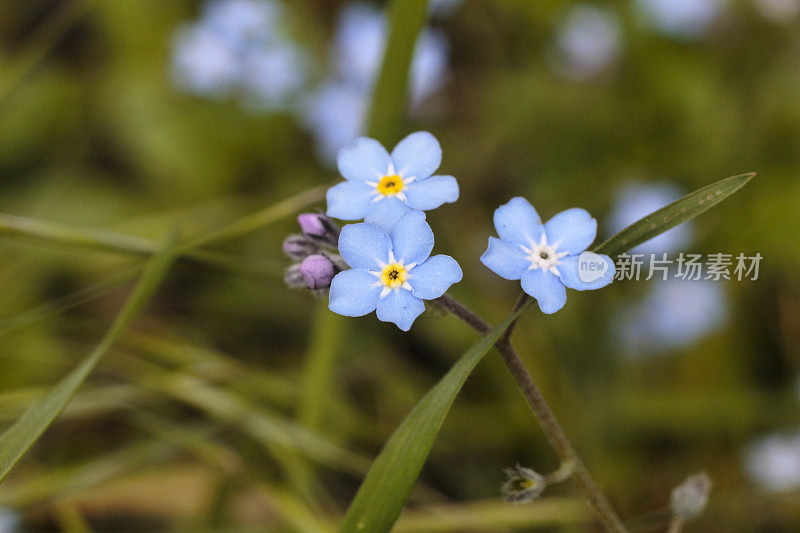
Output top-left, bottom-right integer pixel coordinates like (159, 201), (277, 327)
(327, 131), (458, 232)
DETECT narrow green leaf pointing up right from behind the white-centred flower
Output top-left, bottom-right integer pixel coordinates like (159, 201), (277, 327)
(592, 172), (756, 256)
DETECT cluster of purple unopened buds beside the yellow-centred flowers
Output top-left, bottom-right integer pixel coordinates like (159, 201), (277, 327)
(283, 213), (344, 290)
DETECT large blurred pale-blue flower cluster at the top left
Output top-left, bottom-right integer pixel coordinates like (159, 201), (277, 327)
(172, 0), (308, 110)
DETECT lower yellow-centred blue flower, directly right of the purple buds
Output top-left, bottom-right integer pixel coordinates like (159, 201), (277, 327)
(328, 211), (462, 331)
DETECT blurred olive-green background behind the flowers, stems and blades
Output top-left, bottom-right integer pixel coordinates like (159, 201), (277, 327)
(0, 0), (800, 531)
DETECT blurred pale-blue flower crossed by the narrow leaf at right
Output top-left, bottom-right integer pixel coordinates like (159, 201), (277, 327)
(609, 183), (694, 254)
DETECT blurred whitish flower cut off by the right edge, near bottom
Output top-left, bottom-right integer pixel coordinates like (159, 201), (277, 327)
(744, 433), (800, 492)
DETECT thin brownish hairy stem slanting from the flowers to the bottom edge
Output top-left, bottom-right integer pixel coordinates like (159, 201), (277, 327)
(437, 294), (627, 533)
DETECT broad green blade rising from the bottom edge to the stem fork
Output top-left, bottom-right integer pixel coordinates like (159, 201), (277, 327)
(340, 299), (533, 533)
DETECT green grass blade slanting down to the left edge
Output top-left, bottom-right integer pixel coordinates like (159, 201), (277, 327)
(0, 231), (174, 481)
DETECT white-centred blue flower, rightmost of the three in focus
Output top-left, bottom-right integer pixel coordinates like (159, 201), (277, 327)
(481, 196), (614, 314)
